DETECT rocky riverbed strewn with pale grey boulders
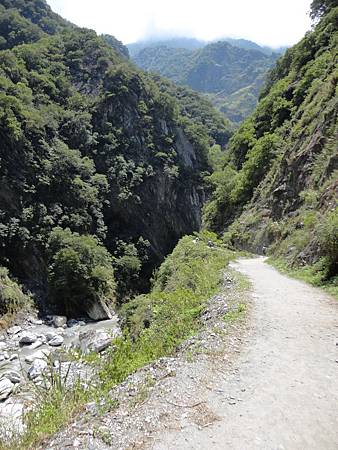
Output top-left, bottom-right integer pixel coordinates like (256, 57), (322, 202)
(0, 315), (121, 435)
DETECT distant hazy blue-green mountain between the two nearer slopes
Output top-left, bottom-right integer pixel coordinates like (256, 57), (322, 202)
(132, 40), (279, 123)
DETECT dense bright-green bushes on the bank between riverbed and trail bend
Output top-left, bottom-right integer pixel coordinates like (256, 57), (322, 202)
(108, 233), (234, 385)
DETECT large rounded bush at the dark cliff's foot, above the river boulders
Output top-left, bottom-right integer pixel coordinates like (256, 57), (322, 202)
(49, 228), (115, 314)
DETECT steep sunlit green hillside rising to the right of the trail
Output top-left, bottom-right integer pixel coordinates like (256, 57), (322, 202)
(205, 2), (338, 288)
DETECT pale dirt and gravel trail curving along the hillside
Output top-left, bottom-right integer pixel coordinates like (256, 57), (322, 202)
(152, 258), (338, 450)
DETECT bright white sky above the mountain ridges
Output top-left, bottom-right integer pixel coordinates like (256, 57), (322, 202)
(47, 0), (312, 47)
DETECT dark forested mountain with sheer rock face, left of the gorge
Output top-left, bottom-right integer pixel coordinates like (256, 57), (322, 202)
(0, 0), (230, 315)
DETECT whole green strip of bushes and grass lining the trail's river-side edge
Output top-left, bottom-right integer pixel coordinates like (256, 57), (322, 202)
(0, 234), (235, 450)
